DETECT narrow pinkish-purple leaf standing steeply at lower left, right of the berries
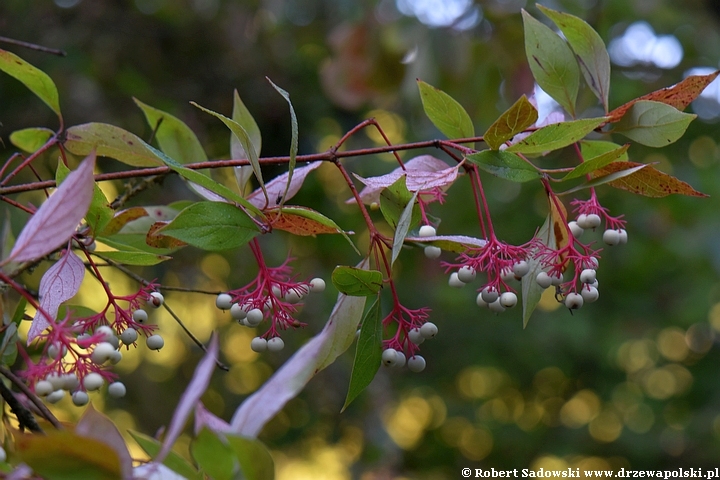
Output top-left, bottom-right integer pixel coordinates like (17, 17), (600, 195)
(155, 335), (218, 463)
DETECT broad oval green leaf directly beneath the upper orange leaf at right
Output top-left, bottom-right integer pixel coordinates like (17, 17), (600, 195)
(613, 100), (697, 147)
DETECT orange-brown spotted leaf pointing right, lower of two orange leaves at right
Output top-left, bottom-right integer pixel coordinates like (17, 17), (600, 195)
(593, 162), (707, 198)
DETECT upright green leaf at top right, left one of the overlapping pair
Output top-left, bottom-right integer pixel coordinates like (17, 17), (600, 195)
(522, 10), (580, 117)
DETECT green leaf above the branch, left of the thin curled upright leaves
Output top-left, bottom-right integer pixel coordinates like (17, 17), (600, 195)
(133, 98), (207, 164)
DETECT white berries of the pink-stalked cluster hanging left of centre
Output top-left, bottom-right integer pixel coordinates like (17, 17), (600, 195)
(215, 278), (325, 353)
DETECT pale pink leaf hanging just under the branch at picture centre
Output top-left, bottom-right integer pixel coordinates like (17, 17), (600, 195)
(347, 155), (459, 205)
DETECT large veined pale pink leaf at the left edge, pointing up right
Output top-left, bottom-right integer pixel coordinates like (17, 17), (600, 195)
(7, 153), (95, 262)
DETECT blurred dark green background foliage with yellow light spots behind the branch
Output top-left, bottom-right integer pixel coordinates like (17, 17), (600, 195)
(0, 0), (720, 479)
